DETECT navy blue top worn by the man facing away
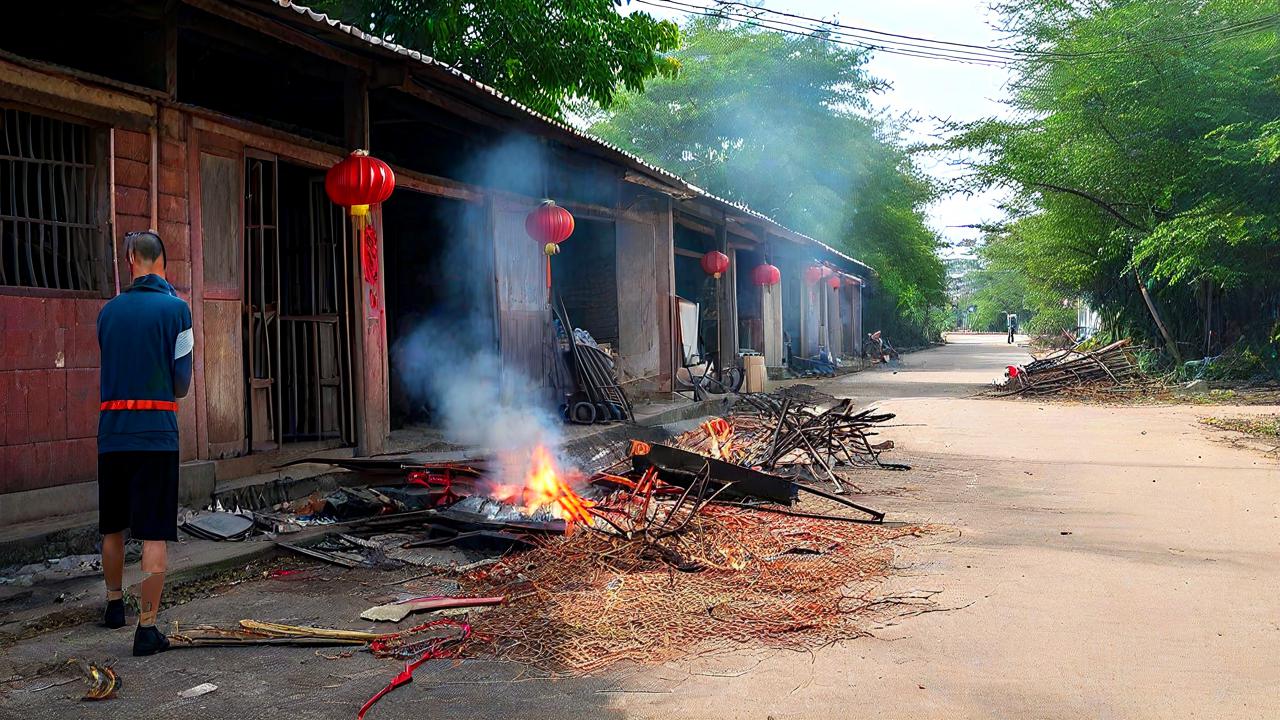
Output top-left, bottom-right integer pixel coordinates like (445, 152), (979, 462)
(97, 275), (195, 452)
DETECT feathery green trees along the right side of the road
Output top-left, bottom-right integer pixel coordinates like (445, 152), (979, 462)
(945, 0), (1280, 356)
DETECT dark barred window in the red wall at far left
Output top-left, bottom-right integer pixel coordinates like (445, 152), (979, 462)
(0, 108), (106, 291)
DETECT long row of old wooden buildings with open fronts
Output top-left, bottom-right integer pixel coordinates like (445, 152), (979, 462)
(0, 0), (869, 524)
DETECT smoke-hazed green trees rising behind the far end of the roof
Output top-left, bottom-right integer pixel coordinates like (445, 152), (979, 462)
(591, 17), (946, 343)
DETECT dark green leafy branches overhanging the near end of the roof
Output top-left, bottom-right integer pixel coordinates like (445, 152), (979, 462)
(309, 0), (680, 118)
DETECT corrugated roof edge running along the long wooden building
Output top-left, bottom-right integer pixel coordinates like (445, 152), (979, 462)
(268, 0), (876, 274)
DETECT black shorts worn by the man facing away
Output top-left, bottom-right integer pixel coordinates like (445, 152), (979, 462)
(97, 451), (178, 541)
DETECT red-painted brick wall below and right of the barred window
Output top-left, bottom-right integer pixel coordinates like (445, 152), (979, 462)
(0, 110), (200, 495)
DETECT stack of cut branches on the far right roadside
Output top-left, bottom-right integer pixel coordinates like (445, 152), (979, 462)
(995, 340), (1142, 397)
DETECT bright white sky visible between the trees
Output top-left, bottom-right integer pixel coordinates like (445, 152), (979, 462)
(625, 0), (1009, 256)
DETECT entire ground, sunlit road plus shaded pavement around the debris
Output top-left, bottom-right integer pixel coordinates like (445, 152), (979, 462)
(0, 336), (1280, 720)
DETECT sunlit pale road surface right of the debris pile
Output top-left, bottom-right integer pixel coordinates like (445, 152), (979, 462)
(645, 336), (1280, 720)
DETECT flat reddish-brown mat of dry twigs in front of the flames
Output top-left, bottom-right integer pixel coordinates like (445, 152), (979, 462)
(465, 505), (928, 674)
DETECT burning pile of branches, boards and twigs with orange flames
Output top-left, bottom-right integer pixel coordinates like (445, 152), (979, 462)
(173, 387), (927, 696)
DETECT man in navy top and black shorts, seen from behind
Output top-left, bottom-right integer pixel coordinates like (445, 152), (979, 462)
(97, 232), (195, 655)
